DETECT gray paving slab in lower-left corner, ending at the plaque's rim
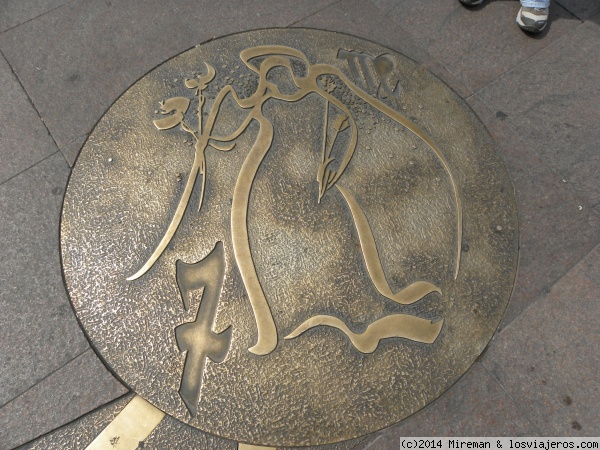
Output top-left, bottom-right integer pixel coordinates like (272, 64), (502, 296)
(0, 349), (127, 450)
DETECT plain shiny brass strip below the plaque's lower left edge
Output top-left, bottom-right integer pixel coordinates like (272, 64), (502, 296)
(86, 395), (165, 450)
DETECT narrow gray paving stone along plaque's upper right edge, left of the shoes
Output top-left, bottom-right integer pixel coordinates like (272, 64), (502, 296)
(294, 0), (472, 98)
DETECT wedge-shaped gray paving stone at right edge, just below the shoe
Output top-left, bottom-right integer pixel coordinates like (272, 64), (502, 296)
(478, 22), (600, 208)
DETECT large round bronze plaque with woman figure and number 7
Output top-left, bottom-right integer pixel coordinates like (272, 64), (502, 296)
(61, 29), (518, 445)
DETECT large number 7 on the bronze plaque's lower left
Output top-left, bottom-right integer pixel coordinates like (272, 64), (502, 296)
(175, 242), (231, 416)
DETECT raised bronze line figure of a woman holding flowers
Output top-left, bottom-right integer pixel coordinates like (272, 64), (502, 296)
(129, 46), (462, 362)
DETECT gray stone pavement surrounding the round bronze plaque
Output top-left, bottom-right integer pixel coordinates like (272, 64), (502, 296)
(0, 0), (600, 450)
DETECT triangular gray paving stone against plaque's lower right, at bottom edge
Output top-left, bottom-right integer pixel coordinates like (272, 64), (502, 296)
(357, 363), (538, 450)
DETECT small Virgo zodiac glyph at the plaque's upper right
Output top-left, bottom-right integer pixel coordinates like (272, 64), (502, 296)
(338, 49), (398, 98)
